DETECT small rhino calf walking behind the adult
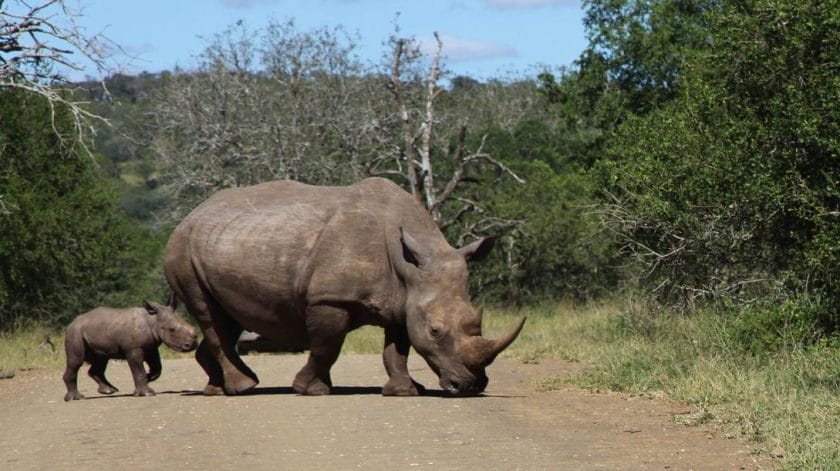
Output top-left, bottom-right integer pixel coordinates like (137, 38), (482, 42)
(63, 294), (198, 401)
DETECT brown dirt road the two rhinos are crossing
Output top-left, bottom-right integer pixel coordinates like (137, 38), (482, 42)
(0, 355), (772, 470)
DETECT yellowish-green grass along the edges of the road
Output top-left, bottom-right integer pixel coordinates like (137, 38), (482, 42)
(0, 301), (840, 470)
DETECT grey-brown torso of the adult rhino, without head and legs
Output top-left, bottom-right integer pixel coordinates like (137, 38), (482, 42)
(166, 179), (446, 331)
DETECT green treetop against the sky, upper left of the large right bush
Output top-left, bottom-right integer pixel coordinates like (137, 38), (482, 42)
(538, 0), (713, 167)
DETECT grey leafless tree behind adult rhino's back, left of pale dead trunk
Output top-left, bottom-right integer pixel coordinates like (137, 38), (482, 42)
(149, 21), (386, 213)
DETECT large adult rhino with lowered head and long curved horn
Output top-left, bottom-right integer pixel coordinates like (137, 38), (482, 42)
(164, 178), (525, 396)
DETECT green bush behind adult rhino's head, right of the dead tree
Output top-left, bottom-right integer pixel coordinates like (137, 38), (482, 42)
(456, 120), (617, 305)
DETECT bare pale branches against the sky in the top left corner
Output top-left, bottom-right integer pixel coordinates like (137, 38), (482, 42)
(0, 0), (115, 145)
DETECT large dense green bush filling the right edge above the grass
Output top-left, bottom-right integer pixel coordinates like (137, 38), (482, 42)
(603, 0), (840, 330)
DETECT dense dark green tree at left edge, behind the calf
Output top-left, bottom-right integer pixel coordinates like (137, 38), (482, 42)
(0, 91), (166, 328)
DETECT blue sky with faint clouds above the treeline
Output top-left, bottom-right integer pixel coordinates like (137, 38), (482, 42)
(72, 0), (586, 79)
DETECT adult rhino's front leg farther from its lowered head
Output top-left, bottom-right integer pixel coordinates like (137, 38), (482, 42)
(292, 305), (350, 395)
